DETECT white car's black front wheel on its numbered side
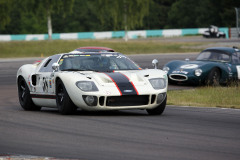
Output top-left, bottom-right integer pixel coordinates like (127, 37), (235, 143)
(56, 79), (77, 115)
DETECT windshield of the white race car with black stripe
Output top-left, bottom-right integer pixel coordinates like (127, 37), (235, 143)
(59, 53), (141, 72)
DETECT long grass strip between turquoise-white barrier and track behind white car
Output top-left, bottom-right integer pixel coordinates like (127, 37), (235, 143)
(0, 39), (203, 58)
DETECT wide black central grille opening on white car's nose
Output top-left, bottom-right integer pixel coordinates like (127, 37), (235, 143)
(106, 95), (149, 106)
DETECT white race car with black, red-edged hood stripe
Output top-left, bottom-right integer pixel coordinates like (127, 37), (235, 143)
(17, 51), (168, 115)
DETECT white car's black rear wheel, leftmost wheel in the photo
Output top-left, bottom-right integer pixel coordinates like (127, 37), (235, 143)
(18, 77), (41, 111)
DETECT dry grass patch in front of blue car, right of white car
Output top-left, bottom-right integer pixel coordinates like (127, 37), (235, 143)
(167, 86), (240, 109)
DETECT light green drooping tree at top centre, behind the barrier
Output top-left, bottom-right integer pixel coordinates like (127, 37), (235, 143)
(95, 0), (149, 30)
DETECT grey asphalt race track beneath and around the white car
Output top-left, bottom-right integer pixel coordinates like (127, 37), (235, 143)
(0, 54), (240, 160)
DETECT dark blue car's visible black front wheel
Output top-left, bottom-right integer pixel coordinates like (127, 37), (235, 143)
(206, 68), (220, 86)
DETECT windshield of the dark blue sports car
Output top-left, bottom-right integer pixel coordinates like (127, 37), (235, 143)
(196, 51), (230, 62)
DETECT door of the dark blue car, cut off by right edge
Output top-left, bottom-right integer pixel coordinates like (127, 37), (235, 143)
(231, 52), (240, 80)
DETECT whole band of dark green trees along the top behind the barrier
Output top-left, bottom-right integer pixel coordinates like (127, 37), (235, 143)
(0, 0), (240, 34)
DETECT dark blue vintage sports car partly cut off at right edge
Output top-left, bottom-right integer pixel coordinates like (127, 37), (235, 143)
(163, 47), (240, 85)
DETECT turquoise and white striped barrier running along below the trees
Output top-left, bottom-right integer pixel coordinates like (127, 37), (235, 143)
(0, 28), (229, 41)
